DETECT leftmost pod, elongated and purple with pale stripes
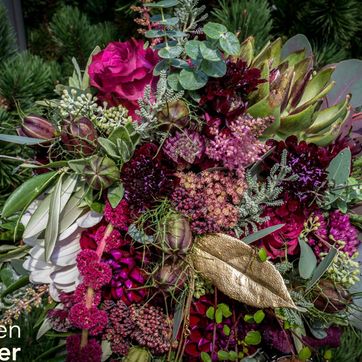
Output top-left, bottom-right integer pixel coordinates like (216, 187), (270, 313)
(18, 115), (56, 140)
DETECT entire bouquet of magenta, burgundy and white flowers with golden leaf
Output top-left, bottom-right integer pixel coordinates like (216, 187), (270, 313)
(0, 0), (362, 362)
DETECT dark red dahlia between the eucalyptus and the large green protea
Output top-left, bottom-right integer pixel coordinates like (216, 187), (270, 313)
(200, 60), (265, 120)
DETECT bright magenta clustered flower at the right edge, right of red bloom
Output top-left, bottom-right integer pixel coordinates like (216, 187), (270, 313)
(308, 210), (361, 257)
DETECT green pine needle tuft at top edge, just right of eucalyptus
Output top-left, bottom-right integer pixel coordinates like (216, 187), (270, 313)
(211, 0), (273, 50)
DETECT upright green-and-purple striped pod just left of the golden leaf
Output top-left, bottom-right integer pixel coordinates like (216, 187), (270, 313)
(162, 214), (192, 254)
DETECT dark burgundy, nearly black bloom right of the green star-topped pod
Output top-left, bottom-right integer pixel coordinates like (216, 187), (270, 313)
(121, 143), (174, 210)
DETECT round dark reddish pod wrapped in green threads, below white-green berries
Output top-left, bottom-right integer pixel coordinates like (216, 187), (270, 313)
(61, 117), (97, 156)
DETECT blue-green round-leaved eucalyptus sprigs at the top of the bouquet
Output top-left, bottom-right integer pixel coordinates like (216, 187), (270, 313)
(146, 0), (240, 91)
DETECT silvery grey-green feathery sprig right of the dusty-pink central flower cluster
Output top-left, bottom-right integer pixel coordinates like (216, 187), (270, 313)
(236, 151), (297, 235)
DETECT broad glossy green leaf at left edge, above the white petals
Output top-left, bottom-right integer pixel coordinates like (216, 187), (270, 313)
(2, 171), (58, 217)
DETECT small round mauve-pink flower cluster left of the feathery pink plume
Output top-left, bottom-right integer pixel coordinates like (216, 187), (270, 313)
(163, 130), (205, 164)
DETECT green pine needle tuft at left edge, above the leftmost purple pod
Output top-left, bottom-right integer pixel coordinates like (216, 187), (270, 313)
(0, 53), (54, 110)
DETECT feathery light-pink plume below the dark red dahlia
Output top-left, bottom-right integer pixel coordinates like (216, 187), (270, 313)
(206, 115), (273, 177)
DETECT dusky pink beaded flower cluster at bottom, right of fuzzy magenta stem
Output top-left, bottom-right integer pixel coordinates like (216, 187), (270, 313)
(103, 301), (172, 355)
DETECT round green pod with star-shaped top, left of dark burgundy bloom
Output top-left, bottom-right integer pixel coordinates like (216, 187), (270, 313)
(83, 156), (120, 190)
